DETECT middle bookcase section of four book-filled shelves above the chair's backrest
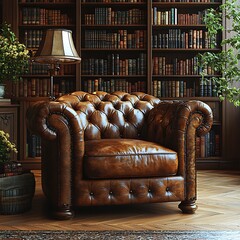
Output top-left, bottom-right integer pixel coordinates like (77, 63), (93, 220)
(81, 1), (147, 92)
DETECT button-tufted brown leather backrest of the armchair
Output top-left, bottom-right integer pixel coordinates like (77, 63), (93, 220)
(56, 91), (160, 140)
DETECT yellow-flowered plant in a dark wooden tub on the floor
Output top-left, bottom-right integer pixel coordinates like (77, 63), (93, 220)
(0, 130), (35, 214)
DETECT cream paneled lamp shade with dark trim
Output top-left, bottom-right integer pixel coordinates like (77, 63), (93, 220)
(34, 29), (81, 64)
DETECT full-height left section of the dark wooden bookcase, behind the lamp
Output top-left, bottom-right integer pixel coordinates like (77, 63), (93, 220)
(9, 0), (79, 168)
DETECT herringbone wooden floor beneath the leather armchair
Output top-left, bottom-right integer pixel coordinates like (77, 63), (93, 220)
(0, 170), (240, 230)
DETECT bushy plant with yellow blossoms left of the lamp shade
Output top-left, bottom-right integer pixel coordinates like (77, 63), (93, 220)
(0, 23), (29, 97)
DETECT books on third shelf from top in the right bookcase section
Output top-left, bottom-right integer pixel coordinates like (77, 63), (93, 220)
(152, 56), (216, 76)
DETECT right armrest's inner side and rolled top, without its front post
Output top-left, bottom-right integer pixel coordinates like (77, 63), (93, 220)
(148, 100), (213, 151)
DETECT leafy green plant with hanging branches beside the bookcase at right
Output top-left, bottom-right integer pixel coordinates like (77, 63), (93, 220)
(199, 0), (240, 106)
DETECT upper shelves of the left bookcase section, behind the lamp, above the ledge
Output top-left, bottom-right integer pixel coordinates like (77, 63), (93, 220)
(13, 0), (76, 97)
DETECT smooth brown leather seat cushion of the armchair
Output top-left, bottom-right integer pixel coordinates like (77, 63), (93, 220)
(84, 138), (178, 179)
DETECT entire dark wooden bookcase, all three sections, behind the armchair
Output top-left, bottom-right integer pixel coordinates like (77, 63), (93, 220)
(3, 0), (227, 169)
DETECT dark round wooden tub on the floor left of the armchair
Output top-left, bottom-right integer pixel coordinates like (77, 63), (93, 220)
(0, 172), (35, 214)
